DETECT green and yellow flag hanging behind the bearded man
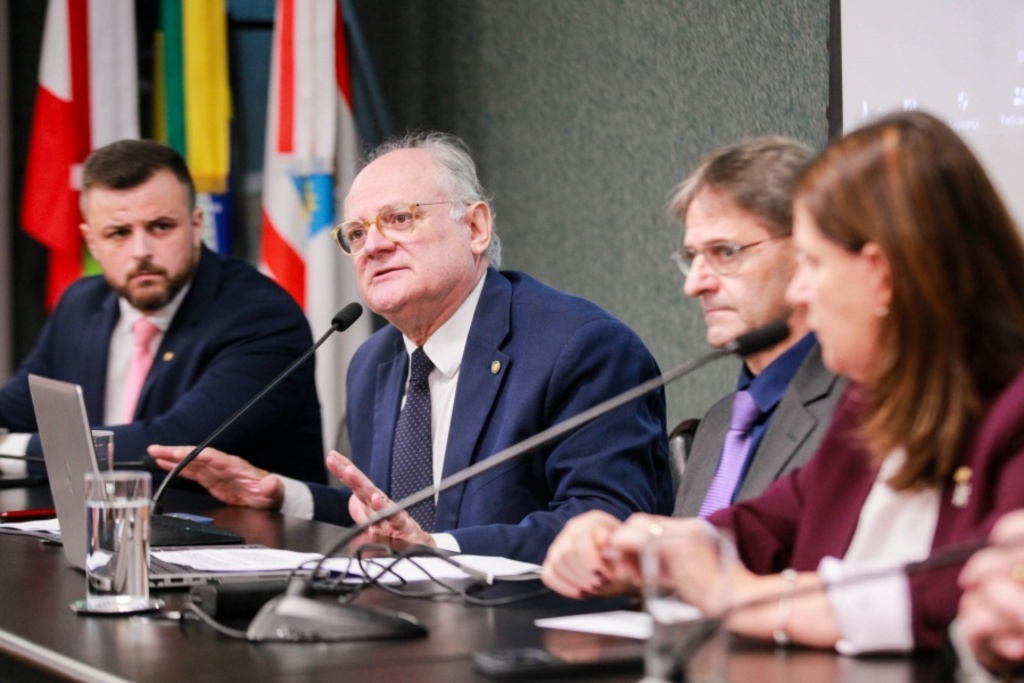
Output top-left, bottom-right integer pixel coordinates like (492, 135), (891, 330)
(153, 0), (231, 253)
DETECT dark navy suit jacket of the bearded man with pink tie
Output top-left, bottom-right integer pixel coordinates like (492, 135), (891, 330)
(0, 248), (326, 481)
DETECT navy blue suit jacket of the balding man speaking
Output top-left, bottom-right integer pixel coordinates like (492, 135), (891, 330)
(311, 269), (672, 562)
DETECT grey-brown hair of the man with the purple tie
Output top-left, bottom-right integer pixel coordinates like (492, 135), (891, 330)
(669, 136), (813, 237)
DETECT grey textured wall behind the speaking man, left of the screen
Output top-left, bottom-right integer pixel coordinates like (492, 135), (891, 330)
(354, 0), (828, 421)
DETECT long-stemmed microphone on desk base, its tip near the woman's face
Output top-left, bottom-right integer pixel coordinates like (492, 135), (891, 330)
(246, 322), (790, 642)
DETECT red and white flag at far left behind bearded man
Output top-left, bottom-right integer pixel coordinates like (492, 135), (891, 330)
(22, 0), (138, 310)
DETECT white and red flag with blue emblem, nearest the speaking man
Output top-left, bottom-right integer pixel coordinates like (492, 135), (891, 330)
(261, 0), (371, 454)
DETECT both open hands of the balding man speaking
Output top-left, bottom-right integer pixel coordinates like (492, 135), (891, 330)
(148, 444), (435, 547)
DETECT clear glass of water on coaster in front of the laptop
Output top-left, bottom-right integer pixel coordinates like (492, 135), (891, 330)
(83, 471), (154, 613)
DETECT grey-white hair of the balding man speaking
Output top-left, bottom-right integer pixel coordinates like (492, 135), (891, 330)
(367, 131), (502, 268)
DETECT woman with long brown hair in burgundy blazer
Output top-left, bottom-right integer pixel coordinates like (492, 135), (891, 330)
(598, 112), (1024, 653)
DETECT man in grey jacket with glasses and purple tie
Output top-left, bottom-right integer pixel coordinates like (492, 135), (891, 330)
(544, 137), (845, 597)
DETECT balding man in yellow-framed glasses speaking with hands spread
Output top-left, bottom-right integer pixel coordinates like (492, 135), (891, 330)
(150, 133), (672, 562)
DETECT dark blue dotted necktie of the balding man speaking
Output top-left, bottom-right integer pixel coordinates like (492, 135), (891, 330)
(391, 347), (434, 532)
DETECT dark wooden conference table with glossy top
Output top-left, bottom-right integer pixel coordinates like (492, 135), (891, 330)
(0, 486), (941, 683)
